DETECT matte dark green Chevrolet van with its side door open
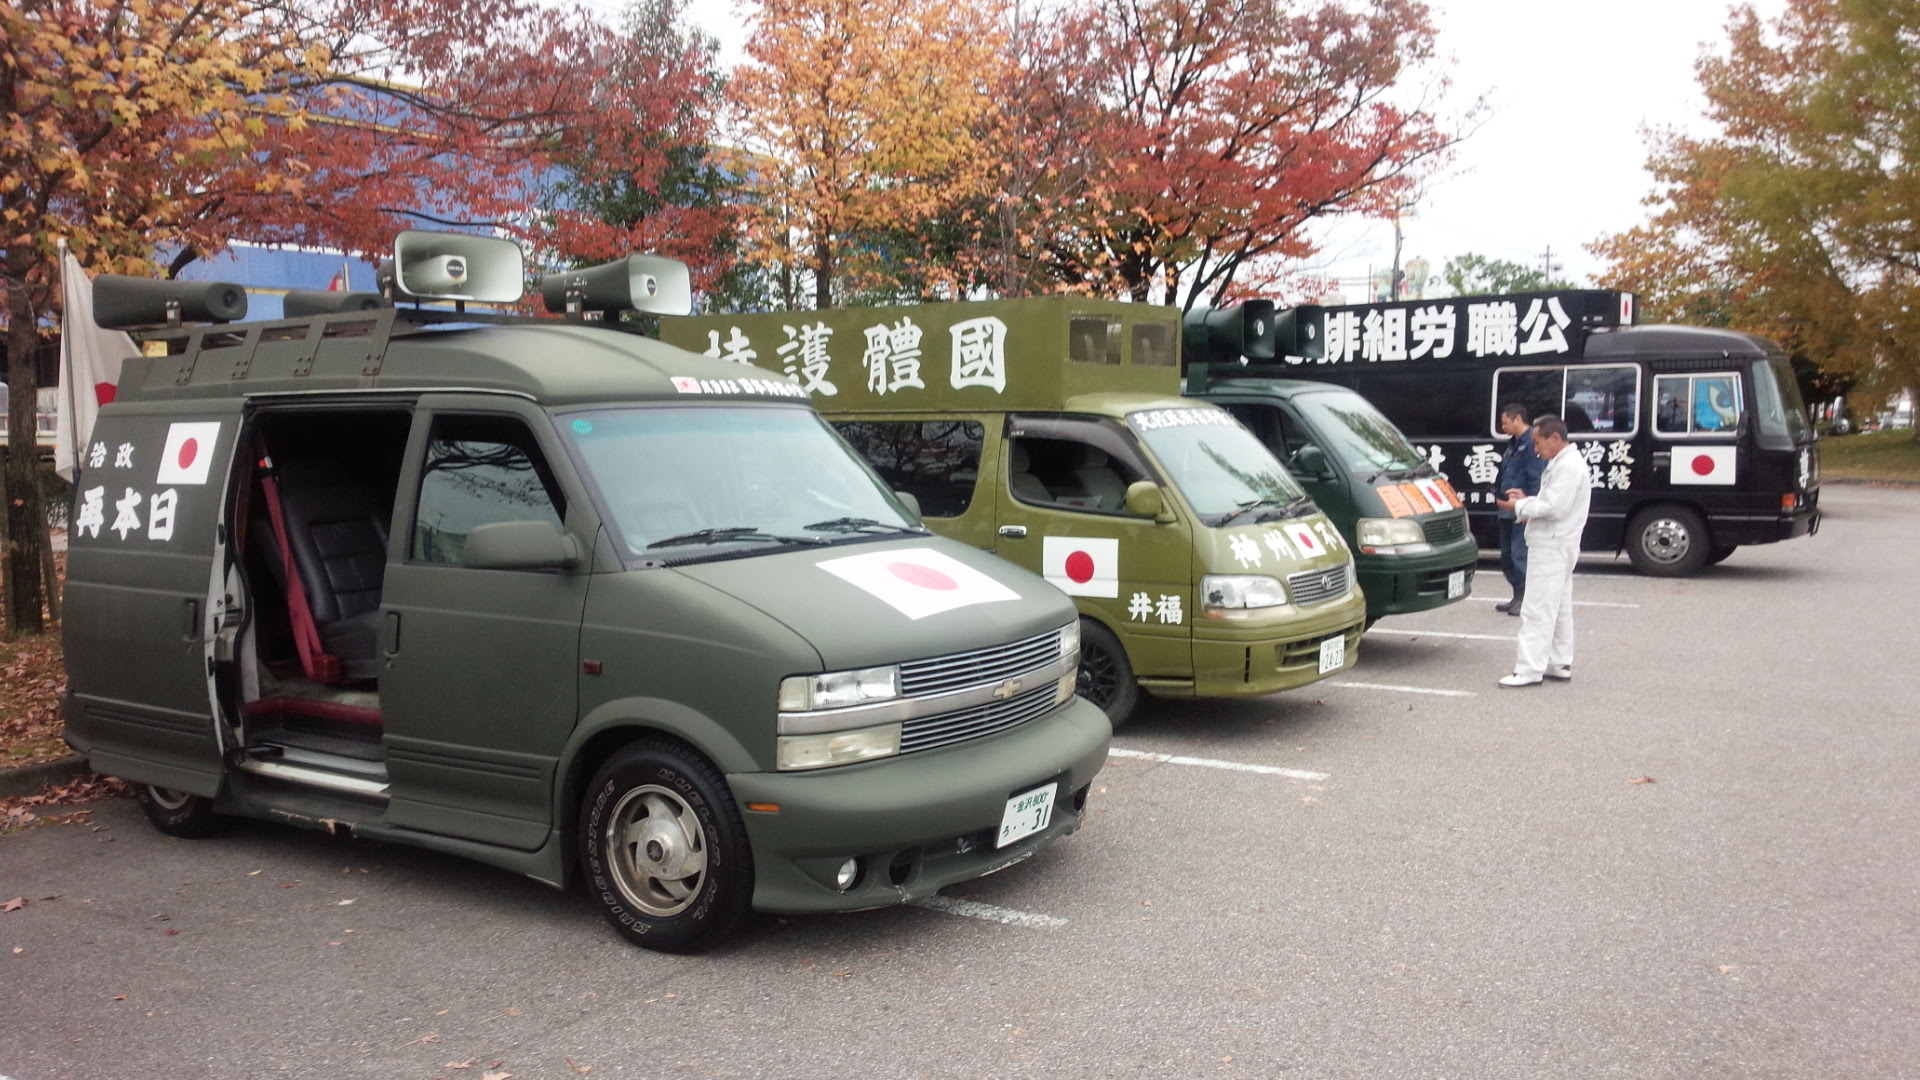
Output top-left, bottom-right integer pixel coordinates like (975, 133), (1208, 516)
(65, 233), (1112, 951)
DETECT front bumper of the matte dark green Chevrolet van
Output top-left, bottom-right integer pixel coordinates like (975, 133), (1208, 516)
(728, 698), (1114, 913)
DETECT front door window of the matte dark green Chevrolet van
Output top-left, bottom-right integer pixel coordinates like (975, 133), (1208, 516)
(413, 417), (566, 563)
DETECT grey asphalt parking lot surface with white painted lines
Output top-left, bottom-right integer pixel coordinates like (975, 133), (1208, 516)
(0, 486), (1920, 1080)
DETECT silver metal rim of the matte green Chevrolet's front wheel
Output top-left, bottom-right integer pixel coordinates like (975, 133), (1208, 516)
(605, 784), (707, 919)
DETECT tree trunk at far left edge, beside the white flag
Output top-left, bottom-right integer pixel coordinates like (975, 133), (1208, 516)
(4, 284), (46, 640)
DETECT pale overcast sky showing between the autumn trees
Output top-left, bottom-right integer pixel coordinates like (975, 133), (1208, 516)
(589, 0), (1784, 300)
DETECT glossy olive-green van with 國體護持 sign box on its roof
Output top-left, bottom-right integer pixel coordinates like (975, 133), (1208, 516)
(660, 298), (1367, 724)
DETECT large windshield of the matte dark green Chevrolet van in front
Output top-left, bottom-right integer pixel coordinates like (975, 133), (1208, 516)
(561, 405), (922, 561)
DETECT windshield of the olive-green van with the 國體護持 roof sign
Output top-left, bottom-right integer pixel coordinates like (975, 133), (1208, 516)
(1127, 409), (1311, 525)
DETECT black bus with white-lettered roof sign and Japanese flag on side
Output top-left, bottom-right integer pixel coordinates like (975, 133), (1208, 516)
(1188, 290), (1820, 575)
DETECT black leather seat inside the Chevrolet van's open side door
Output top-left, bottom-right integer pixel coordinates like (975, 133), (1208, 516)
(278, 459), (388, 678)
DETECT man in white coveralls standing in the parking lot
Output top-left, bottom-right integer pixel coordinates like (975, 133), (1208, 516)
(1494, 413), (1594, 686)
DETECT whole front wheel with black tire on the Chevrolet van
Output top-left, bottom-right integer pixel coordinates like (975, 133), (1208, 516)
(580, 738), (753, 953)
